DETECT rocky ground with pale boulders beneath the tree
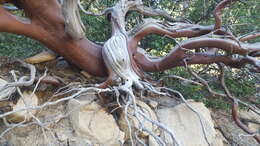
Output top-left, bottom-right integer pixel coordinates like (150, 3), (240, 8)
(0, 57), (260, 146)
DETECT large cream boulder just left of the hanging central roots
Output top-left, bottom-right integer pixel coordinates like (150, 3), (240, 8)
(68, 99), (124, 146)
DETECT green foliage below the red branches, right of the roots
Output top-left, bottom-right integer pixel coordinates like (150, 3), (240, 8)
(159, 67), (259, 109)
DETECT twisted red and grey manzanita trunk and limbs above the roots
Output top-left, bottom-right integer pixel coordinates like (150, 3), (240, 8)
(0, 0), (260, 142)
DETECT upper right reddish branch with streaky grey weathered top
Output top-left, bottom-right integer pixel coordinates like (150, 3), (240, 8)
(129, 19), (214, 50)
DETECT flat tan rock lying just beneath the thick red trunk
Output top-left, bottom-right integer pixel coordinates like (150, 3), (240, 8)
(25, 51), (57, 64)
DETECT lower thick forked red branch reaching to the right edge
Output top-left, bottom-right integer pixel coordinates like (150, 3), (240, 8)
(134, 38), (260, 72)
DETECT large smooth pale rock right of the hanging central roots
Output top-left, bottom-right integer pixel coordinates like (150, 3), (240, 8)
(157, 102), (218, 146)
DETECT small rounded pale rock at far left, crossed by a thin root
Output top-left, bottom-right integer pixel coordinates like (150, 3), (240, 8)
(7, 91), (39, 123)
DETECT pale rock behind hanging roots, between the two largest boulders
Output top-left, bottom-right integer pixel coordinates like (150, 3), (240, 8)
(119, 100), (159, 139)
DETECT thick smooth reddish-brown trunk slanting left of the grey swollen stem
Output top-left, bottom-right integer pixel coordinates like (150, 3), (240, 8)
(0, 0), (107, 76)
